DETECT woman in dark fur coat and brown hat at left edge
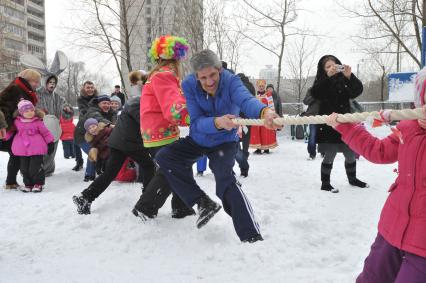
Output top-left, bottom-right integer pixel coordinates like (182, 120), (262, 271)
(0, 69), (41, 189)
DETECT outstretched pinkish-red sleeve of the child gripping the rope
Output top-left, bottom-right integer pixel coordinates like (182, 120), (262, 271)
(335, 123), (400, 164)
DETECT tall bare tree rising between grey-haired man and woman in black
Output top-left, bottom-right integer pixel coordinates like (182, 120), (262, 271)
(238, 0), (298, 94)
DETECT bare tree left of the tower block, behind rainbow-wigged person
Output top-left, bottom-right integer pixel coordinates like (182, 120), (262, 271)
(65, 0), (145, 95)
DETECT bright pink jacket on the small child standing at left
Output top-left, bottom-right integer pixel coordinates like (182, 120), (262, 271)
(12, 116), (54, 156)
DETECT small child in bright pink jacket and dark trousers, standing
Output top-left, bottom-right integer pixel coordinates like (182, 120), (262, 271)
(12, 100), (54, 193)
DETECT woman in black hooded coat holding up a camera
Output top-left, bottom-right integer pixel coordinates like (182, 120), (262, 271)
(311, 55), (367, 193)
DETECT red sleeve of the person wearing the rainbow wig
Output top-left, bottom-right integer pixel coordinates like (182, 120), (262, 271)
(151, 71), (189, 125)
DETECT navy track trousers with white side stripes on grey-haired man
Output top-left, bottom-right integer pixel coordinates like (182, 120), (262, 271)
(155, 137), (260, 241)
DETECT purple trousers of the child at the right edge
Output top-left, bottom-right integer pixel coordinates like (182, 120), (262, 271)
(356, 233), (426, 283)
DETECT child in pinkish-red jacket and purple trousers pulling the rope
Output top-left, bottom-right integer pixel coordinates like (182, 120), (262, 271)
(328, 68), (426, 283)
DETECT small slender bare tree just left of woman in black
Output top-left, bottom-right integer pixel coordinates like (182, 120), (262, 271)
(286, 33), (318, 111)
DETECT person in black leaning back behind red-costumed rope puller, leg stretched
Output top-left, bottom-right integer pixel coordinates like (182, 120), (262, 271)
(73, 97), (154, 214)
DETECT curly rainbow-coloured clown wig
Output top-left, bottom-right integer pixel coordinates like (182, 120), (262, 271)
(149, 35), (189, 63)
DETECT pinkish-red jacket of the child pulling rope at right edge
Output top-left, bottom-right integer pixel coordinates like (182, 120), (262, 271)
(336, 120), (426, 257)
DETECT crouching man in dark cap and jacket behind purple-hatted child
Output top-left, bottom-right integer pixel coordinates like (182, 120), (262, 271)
(74, 95), (117, 182)
